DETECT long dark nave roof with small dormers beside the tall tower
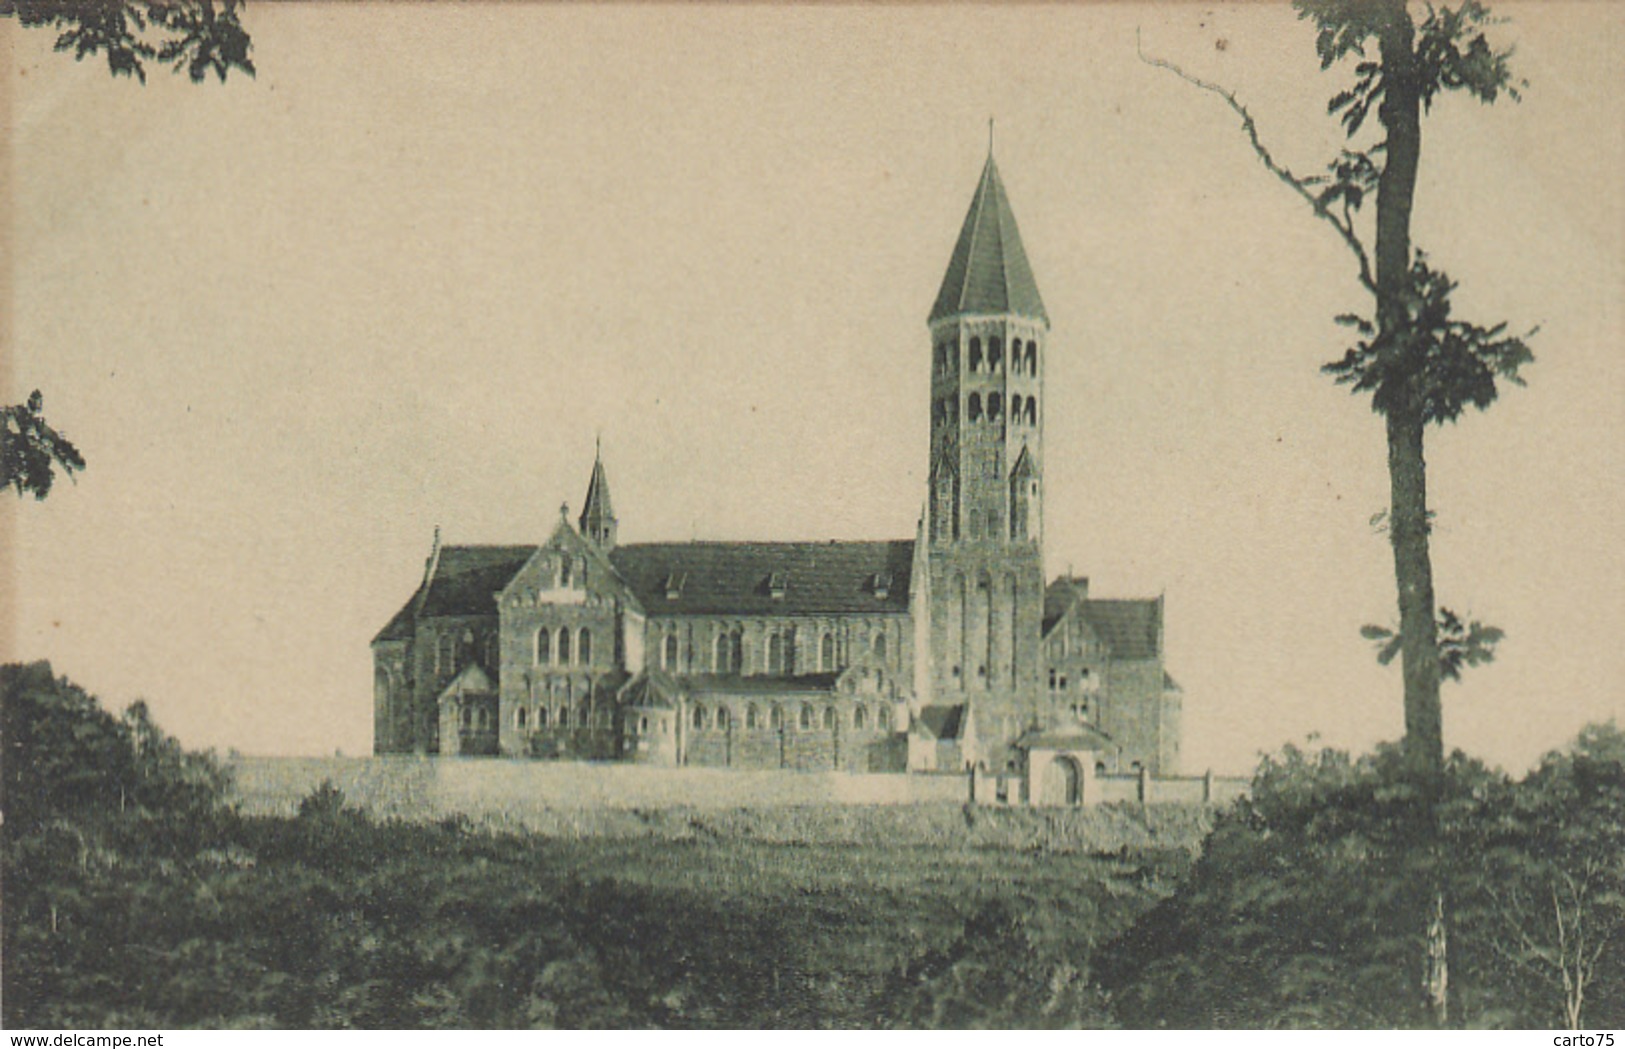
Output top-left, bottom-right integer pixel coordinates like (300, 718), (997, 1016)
(609, 539), (913, 615)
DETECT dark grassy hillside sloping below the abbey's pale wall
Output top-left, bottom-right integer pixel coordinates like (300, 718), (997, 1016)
(5, 799), (1188, 1028)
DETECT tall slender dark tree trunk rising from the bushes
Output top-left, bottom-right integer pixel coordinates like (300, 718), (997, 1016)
(1375, 0), (1450, 1028)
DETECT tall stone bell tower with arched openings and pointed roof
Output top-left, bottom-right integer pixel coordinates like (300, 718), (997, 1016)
(925, 145), (1050, 763)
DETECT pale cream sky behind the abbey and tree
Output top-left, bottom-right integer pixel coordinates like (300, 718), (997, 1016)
(0, 3), (1625, 771)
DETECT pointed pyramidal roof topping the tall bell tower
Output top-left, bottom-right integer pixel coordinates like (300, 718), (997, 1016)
(931, 153), (1050, 323)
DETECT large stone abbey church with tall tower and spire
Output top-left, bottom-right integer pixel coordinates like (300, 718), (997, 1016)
(372, 153), (1181, 776)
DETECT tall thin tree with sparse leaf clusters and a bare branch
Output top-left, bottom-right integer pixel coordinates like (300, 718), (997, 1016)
(1146, 0), (1534, 1025)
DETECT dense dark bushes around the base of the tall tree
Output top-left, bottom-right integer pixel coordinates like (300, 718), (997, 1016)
(1099, 726), (1625, 1028)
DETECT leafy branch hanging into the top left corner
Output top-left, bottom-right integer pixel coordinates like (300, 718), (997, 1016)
(0, 0), (254, 83)
